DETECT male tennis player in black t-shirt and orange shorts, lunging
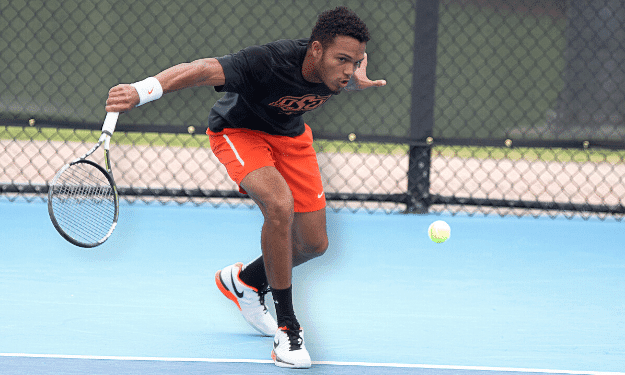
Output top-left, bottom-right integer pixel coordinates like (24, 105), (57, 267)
(106, 7), (386, 368)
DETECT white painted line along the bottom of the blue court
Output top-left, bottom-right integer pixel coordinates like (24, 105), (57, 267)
(0, 353), (625, 375)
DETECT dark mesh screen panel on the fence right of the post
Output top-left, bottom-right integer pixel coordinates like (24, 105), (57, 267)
(434, 0), (625, 148)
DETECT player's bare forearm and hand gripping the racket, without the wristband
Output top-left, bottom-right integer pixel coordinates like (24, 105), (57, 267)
(105, 58), (226, 112)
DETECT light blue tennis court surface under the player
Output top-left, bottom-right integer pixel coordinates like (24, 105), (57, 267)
(0, 200), (625, 375)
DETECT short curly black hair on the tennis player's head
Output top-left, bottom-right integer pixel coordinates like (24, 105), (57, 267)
(308, 6), (370, 47)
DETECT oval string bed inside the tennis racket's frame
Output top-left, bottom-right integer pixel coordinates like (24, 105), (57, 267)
(52, 163), (116, 244)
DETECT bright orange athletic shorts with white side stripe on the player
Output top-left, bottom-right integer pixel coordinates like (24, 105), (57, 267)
(206, 125), (326, 212)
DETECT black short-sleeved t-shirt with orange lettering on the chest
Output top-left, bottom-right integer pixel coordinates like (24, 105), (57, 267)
(208, 39), (332, 137)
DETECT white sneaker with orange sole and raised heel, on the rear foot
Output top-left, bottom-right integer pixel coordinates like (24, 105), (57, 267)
(215, 263), (278, 336)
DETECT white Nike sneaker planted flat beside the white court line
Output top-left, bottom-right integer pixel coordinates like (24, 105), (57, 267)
(271, 327), (312, 368)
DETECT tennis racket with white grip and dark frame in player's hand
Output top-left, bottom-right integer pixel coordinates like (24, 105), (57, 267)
(48, 112), (119, 248)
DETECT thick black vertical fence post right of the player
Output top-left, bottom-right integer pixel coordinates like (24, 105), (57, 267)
(406, 0), (439, 213)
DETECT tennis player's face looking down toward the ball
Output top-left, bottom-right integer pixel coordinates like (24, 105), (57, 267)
(317, 35), (367, 93)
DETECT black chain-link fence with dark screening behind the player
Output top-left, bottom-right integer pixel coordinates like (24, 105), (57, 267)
(0, 0), (625, 219)
